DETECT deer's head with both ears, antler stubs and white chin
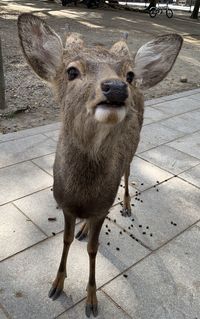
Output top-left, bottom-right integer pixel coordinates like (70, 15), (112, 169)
(18, 14), (182, 126)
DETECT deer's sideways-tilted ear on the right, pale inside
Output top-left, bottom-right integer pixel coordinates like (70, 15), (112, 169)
(134, 34), (183, 89)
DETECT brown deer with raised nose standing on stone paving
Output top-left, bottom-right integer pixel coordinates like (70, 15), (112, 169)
(18, 13), (183, 317)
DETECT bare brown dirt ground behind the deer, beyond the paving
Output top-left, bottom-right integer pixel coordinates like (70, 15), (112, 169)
(0, 0), (200, 133)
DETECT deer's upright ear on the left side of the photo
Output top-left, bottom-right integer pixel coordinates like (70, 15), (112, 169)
(18, 13), (63, 82)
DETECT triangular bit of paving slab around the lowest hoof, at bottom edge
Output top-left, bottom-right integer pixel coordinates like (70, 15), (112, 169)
(56, 291), (132, 319)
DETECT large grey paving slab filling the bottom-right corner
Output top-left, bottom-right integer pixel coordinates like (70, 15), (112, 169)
(103, 227), (200, 319)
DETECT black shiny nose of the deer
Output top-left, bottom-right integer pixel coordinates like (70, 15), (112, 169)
(101, 80), (128, 104)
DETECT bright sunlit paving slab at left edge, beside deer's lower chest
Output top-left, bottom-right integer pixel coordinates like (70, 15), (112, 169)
(0, 162), (53, 205)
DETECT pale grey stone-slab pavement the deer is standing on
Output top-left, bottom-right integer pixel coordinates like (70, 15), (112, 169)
(0, 89), (200, 319)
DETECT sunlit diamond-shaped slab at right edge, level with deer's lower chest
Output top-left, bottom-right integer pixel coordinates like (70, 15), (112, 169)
(139, 145), (200, 174)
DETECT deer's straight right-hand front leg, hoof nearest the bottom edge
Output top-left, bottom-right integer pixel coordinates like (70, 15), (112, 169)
(85, 217), (105, 317)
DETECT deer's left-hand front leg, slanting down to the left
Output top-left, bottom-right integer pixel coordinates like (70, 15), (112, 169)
(49, 210), (76, 300)
